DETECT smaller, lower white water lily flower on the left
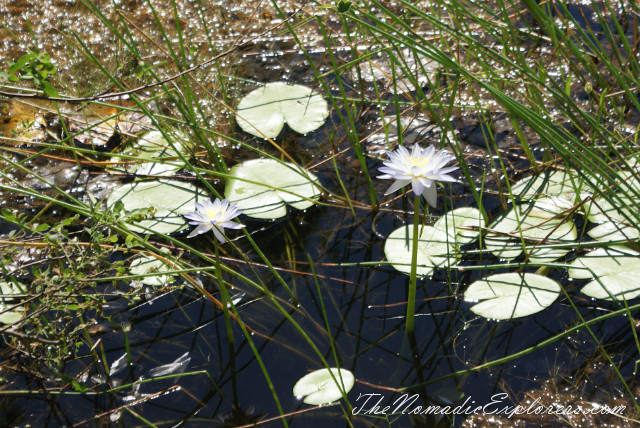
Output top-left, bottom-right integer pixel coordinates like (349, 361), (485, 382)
(184, 198), (244, 242)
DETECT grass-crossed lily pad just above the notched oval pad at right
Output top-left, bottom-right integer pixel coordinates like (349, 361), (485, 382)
(485, 204), (577, 263)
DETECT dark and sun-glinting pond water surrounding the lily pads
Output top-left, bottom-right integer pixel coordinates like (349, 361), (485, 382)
(0, 0), (638, 427)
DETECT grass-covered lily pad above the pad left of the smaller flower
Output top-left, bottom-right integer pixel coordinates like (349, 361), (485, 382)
(111, 131), (189, 176)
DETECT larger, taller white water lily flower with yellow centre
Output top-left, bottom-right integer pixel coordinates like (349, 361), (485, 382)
(378, 144), (458, 208)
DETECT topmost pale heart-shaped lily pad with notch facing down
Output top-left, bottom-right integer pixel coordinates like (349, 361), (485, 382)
(236, 82), (329, 138)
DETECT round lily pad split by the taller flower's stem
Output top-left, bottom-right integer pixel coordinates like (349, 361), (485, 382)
(384, 224), (456, 276)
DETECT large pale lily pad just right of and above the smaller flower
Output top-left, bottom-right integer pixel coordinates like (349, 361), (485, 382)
(224, 159), (320, 219)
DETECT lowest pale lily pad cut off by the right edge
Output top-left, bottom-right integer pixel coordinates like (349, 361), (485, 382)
(569, 247), (640, 301)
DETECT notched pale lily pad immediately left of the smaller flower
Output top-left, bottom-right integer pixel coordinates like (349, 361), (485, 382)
(107, 180), (208, 234)
